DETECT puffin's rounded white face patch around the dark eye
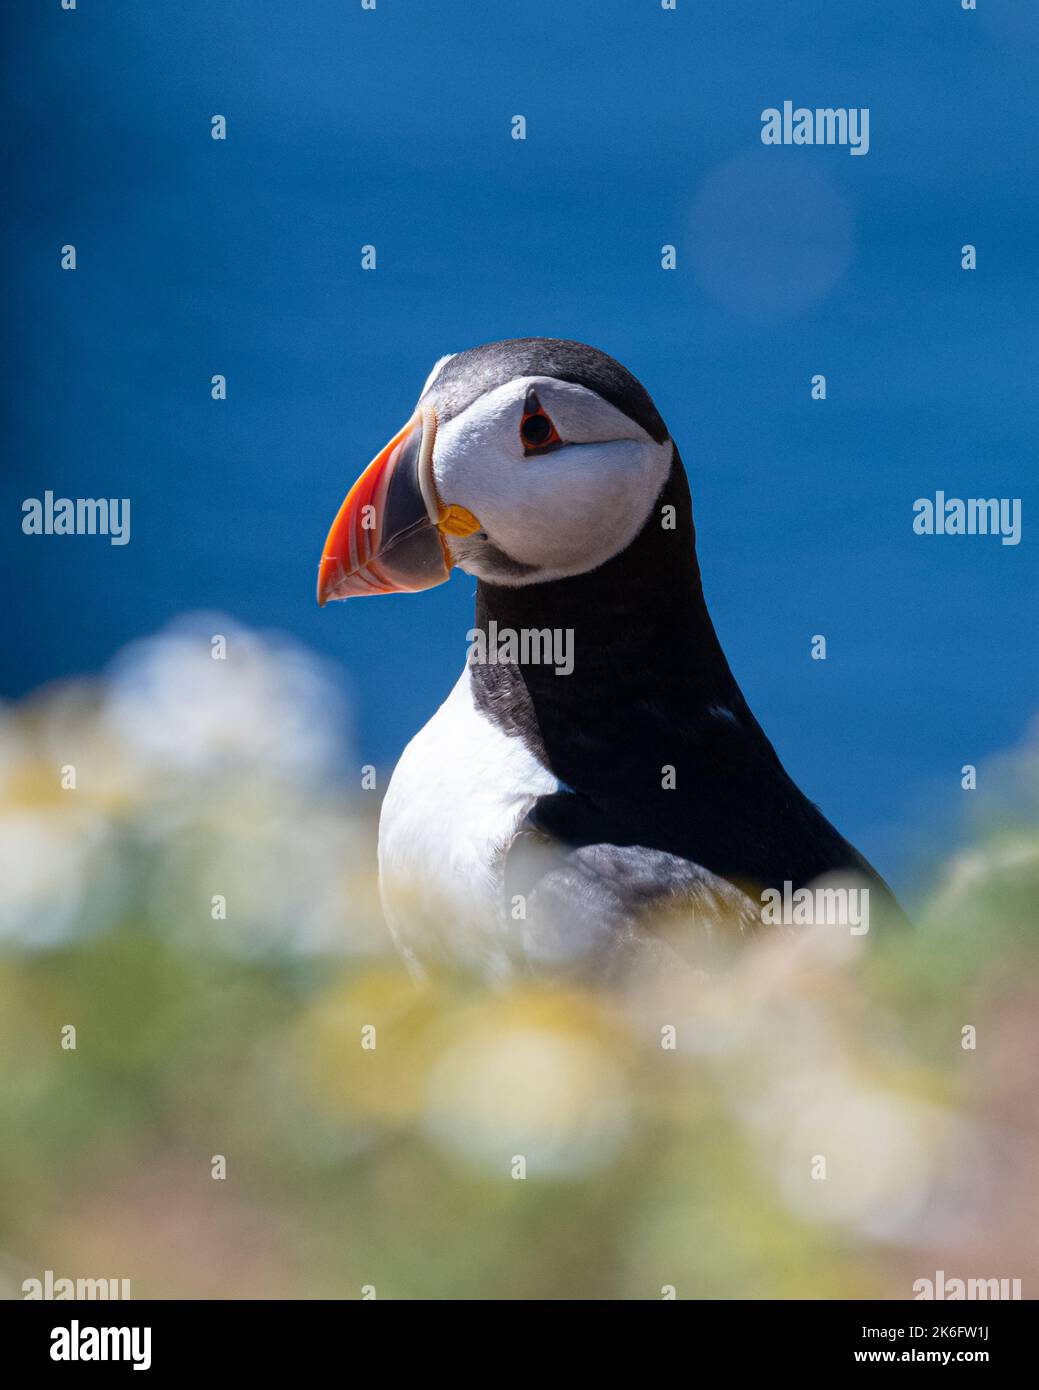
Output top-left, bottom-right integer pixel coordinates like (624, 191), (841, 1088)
(423, 363), (672, 585)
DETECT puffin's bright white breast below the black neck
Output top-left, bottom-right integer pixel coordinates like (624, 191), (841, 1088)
(378, 670), (559, 976)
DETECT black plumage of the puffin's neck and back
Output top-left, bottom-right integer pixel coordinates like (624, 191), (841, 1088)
(470, 449), (901, 901)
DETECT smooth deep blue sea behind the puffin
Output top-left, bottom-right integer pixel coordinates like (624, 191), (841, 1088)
(0, 0), (1039, 887)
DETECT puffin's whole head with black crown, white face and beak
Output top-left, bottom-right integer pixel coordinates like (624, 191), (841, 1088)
(317, 338), (672, 603)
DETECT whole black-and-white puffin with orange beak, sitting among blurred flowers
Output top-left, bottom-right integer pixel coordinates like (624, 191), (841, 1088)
(317, 338), (904, 980)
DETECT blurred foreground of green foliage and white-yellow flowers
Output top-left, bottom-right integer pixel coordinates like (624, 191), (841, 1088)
(0, 630), (1039, 1298)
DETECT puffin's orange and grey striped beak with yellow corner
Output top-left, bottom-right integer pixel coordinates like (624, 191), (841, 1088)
(317, 409), (478, 605)
